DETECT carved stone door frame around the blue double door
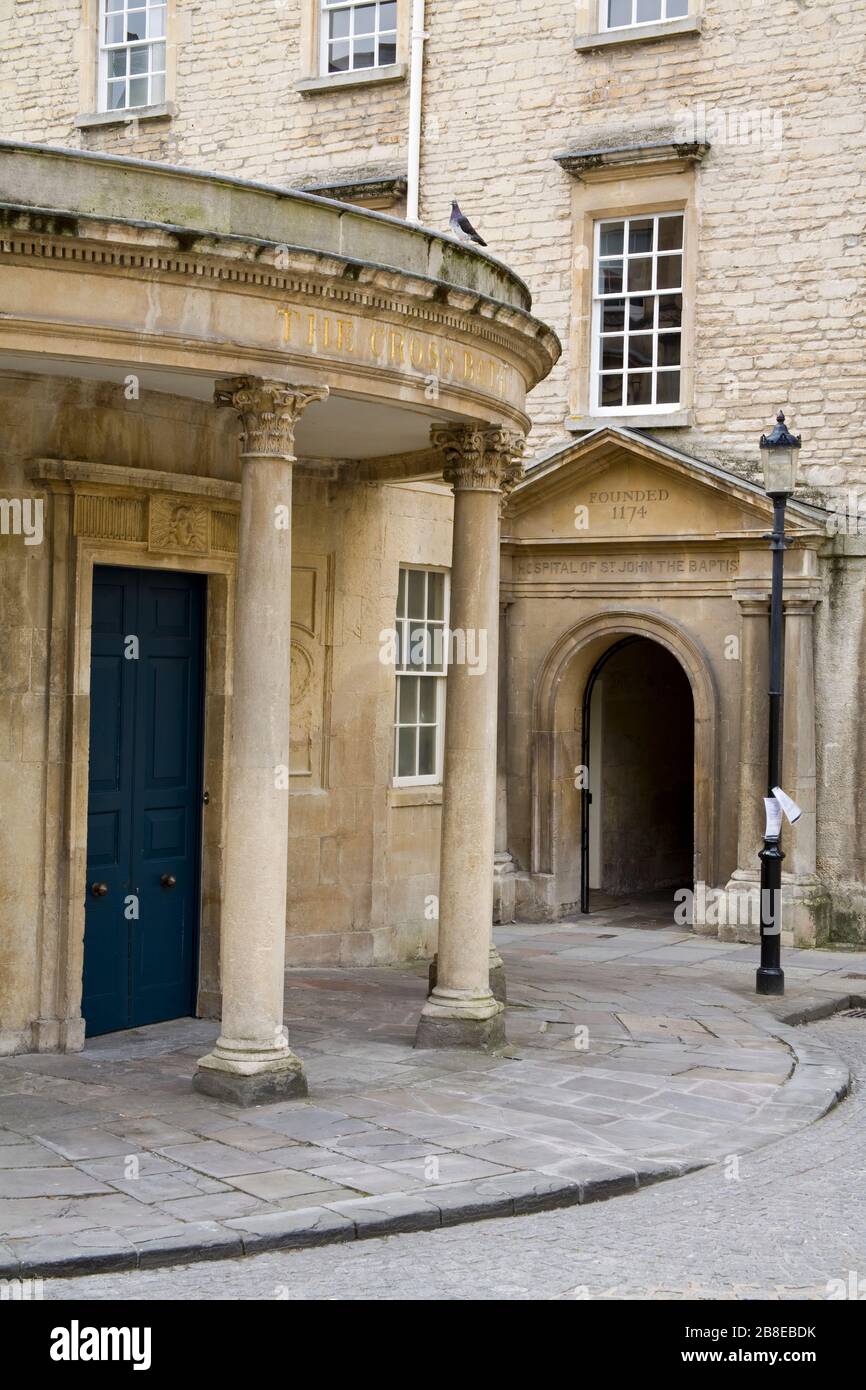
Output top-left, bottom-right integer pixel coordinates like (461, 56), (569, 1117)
(32, 460), (240, 1052)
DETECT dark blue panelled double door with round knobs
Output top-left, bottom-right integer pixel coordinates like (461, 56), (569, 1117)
(82, 567), (204, 1037)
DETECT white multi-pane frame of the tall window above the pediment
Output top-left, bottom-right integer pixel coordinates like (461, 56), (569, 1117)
(589, 209), (687, 416)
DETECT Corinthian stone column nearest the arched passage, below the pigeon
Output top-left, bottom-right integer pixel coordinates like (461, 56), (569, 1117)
(416, 425), (523, 1047)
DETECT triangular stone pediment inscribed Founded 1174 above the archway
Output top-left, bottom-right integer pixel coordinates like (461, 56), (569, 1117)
(503, 427), (824, 545)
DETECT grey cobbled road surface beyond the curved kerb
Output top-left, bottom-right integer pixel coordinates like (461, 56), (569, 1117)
(46, 1016), (866, 1300)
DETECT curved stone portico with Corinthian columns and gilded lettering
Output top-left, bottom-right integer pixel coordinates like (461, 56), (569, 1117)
(0, 142), (559, 1084)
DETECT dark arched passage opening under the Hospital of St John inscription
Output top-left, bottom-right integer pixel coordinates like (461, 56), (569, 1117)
(580, 634), (695, 912)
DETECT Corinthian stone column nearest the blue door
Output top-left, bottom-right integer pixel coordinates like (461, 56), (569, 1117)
(193, 377), (328, 1105)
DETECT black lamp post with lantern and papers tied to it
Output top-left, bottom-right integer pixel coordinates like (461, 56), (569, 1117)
(755, 410), (801, 994)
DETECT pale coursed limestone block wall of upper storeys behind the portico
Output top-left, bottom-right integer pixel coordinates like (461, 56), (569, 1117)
(0, 0), (866, 488)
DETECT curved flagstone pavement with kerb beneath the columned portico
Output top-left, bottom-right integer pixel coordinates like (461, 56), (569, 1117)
(0, 906), (866, 1276)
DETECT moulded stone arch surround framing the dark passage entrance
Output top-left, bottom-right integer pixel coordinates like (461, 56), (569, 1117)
(531, 607), (719, 916)
